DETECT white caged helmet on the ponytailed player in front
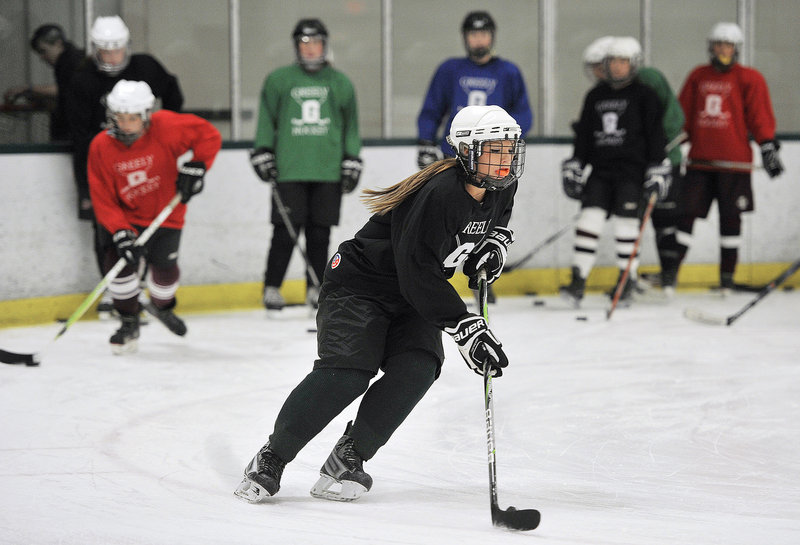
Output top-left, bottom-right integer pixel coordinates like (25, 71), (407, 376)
(447, 106), (525, 191)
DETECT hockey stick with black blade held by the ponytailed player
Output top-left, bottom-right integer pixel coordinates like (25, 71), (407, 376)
(478, 269), (541, 530)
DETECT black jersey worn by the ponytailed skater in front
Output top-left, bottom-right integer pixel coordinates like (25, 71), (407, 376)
(325, 166), (517, 328)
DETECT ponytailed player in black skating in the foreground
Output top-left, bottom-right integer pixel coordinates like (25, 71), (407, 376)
(235, 106), (525, 503)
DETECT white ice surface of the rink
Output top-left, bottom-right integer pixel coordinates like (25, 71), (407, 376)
(0, 292), (800, 545)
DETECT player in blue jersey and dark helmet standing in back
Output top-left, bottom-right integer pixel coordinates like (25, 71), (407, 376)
(417, 11), (533, 168)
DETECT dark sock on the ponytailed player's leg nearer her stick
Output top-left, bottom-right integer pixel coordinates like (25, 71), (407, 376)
(350, 351), (438, 460)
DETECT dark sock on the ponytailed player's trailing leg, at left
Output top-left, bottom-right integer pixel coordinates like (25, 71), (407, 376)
(269, 367), (372, 462)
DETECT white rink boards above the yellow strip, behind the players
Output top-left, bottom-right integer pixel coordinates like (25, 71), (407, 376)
(0, 141), (800, 301)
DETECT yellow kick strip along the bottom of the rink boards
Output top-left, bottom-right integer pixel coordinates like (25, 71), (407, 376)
(0, 263), (800, 328)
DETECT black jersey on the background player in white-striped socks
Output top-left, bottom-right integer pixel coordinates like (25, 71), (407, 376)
(575, 79), (666, 169)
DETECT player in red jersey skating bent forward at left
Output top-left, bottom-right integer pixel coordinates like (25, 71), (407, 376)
(88, 80), (222, 354)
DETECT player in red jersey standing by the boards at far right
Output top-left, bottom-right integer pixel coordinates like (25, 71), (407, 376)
(678, 23), (783, 290)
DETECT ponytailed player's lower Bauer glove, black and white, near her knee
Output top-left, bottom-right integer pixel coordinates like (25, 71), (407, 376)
(444, 314), (508, 377)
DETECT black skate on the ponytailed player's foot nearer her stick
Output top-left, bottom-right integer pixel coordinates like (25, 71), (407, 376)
(311, 422), (372, 501)
